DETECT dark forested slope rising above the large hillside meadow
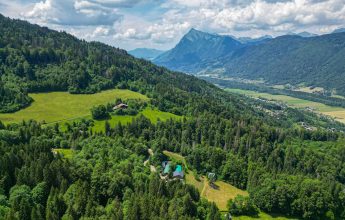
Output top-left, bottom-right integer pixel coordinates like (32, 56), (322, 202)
(0, 15), (235, 114)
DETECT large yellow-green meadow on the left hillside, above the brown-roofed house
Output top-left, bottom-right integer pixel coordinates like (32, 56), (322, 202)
(0, 89), (149, 123)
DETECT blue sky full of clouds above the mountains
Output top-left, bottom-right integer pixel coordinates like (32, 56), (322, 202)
(0, 0), (345, 50)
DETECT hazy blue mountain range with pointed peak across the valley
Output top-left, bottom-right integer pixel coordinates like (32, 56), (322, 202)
(153, 29), (345, 95)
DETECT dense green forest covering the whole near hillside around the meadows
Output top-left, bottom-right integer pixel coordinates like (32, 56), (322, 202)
(0, 14), (345, 220)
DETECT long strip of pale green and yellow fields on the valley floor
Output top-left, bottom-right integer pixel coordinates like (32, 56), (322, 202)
(226, 89), (345, 123)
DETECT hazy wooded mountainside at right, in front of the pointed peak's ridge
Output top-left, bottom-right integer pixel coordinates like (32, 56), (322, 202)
(221, 33), (345, 94)
